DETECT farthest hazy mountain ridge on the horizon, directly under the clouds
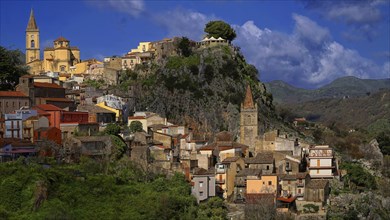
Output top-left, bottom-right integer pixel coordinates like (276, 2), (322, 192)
(265, 76), (390, 104)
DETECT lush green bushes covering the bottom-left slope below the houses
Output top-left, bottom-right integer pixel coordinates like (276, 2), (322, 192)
(0, 158), (226, 220)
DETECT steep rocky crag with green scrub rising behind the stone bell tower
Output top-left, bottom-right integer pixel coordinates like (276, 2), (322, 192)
(119, 42), (275, 137)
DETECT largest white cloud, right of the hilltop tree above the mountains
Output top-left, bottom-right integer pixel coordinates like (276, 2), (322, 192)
(234, 14), (390, 87)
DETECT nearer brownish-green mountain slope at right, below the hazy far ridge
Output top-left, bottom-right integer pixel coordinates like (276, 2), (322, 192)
(286, 89), (390, 129)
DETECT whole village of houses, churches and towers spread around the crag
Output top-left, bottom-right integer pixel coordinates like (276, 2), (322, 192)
(0, 11), (348, 219)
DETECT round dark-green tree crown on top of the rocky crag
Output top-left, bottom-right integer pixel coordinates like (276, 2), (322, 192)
(204, 21), (237, 41)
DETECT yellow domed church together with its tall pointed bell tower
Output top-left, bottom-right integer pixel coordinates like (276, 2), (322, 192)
(26, 9), (80, 75)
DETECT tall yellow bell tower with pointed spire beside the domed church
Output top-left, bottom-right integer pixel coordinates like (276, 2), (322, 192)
(26, 9), (40, 64)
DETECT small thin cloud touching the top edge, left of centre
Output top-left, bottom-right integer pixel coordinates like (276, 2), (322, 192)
(87, 0), (144, 17)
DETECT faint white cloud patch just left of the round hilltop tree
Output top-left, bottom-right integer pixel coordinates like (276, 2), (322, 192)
(154, 8), (216, 40)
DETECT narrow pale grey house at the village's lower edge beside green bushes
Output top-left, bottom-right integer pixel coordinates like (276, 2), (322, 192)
(191, 168), (216, 203)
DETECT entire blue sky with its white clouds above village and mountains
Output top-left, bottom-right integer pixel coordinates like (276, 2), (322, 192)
(0, 0), (390, 88)
